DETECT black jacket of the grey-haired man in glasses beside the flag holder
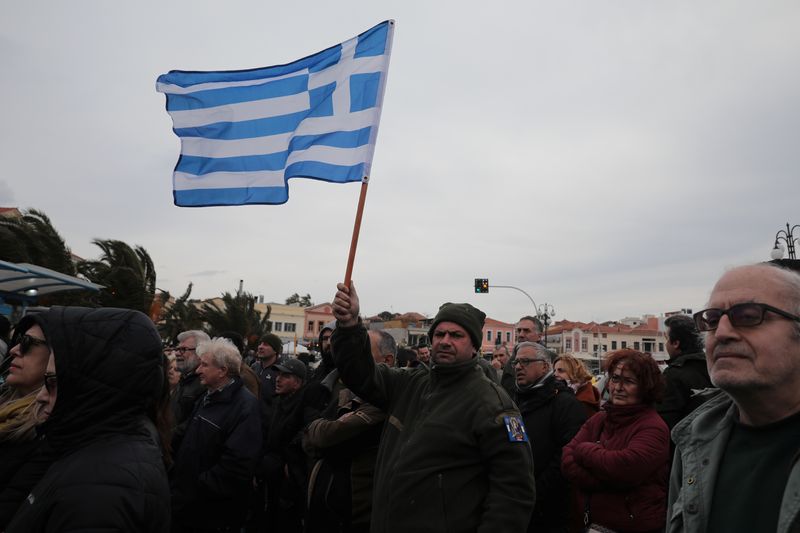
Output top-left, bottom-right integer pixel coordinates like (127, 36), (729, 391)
(514, 374), (586, 532)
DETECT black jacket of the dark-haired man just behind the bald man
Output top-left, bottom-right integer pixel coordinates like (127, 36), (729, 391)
(656, 352), (714, 430)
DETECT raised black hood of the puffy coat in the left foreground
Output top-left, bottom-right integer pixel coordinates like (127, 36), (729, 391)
(42, 307), (167, 451)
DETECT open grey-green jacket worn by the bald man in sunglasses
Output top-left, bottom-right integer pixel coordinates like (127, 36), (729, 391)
(667, 390), (800, 533)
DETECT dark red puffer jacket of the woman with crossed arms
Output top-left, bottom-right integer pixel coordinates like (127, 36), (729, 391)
(561, 404), (669, 532)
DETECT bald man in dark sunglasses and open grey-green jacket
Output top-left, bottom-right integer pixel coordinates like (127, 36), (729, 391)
(667, 264), (800, 533)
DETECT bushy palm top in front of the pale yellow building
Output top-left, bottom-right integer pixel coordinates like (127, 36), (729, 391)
(200, 292), (272, 345)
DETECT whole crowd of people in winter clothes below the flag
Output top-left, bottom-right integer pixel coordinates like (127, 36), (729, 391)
(0, 264), (800, 533)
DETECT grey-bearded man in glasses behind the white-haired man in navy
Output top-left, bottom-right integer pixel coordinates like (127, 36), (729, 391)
(170, 330), (211, 452)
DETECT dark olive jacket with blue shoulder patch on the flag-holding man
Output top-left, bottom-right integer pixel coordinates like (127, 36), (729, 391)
(333, 325), (535, 533)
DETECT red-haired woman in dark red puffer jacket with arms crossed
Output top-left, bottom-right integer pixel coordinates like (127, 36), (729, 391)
(561, 350), (669, 532)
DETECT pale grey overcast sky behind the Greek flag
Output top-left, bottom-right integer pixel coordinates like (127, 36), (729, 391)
(0, 0), (800, 321)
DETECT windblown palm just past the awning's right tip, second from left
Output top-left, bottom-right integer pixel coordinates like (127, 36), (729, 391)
(78, 239), (156, 315)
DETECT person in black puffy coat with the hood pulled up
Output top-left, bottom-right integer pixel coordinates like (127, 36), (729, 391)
(6, 307), (170, 533)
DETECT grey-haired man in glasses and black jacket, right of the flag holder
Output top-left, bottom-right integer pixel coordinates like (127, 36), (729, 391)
(512, 341), (586, 532)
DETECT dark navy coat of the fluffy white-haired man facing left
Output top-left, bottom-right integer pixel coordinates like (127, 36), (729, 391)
(170, 377), (262, 529)
